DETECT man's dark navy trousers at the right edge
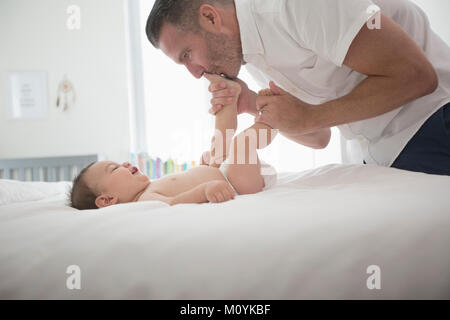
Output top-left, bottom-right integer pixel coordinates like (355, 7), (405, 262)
(391, 103), (450, 176)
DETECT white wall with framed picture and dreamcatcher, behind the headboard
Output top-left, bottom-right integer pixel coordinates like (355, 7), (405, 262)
(0, 0), (130, 161)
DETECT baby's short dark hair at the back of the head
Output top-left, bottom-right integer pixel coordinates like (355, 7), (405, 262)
(70, 162), (98, 210)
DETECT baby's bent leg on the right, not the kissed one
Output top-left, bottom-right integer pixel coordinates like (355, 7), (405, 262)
(225, 123), (276, 194)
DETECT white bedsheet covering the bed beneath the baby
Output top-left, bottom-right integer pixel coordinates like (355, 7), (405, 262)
(0, 165), (450, 299)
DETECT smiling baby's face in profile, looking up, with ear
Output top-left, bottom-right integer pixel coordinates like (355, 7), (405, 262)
(86, 161), (150, 207)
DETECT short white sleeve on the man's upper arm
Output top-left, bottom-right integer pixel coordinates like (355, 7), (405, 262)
(280, 0), (380, 67)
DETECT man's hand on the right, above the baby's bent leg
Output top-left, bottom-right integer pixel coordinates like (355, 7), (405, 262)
(255, 81), (313, 135)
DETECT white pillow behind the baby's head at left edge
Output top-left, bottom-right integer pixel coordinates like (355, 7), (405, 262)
(0, 179), (72, 206)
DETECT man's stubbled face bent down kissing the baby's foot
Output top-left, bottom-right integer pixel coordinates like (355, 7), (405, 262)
(159, 23), (243, 79)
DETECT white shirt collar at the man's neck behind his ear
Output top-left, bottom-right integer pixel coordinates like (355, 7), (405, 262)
(234, 0), (264, 56)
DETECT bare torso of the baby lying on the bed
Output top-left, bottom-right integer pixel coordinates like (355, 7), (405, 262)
(138, 166), (226, 201)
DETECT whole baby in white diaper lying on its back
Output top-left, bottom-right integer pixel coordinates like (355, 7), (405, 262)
(70, 75), (276, 210)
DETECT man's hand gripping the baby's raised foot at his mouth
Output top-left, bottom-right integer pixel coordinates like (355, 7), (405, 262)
(208, 78), (256, 115)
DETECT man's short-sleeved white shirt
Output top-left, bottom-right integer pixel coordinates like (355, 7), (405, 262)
(235, 0), (450, 166)
